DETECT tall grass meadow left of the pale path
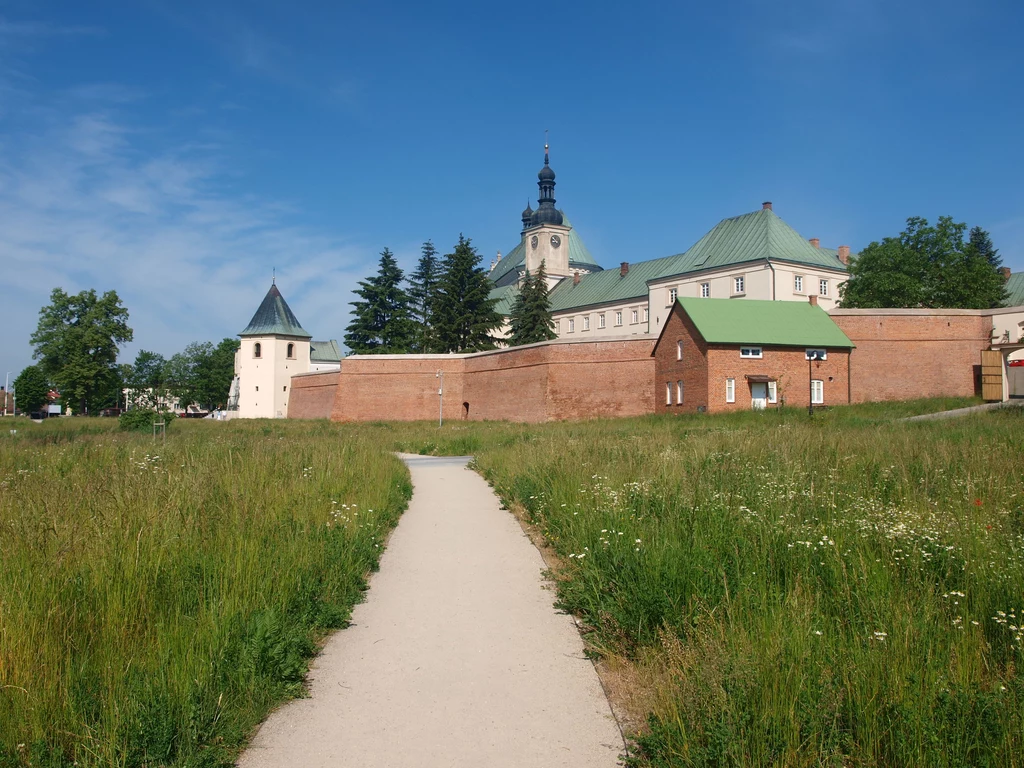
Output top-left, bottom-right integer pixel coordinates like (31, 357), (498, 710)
(0, 420), (411, 766)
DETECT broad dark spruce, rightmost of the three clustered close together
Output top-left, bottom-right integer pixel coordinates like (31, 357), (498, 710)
(433, 234), (502, 352)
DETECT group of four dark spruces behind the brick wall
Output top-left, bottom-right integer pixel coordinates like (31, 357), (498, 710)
(344, 234), (556, 354)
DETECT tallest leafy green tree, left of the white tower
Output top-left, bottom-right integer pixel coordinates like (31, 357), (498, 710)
(31, 288), (132, 413)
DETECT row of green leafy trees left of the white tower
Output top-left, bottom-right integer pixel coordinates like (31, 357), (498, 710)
(14, 288), (239, 414)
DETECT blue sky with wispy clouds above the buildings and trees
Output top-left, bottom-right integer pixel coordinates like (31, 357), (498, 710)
(0, 0), (1024, 375)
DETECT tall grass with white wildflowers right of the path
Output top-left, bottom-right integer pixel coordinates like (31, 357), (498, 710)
(391, 403), (1024, 766)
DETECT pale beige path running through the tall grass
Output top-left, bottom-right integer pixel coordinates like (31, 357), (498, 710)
(239, 456), (624, 768)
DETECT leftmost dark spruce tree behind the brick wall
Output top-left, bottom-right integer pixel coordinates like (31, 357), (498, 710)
(345, 248), (414, 354)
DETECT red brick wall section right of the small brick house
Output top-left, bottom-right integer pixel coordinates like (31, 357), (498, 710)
(829, 309), (992, 402)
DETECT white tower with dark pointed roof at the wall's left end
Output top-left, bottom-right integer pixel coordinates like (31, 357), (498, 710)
(231, 281), (312, 419)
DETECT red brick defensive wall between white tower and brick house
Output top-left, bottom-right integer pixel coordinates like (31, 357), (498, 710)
(288, 336), (654, 423)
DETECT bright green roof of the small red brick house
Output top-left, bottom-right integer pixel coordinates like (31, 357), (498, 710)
(677, 297), (853, 348)
